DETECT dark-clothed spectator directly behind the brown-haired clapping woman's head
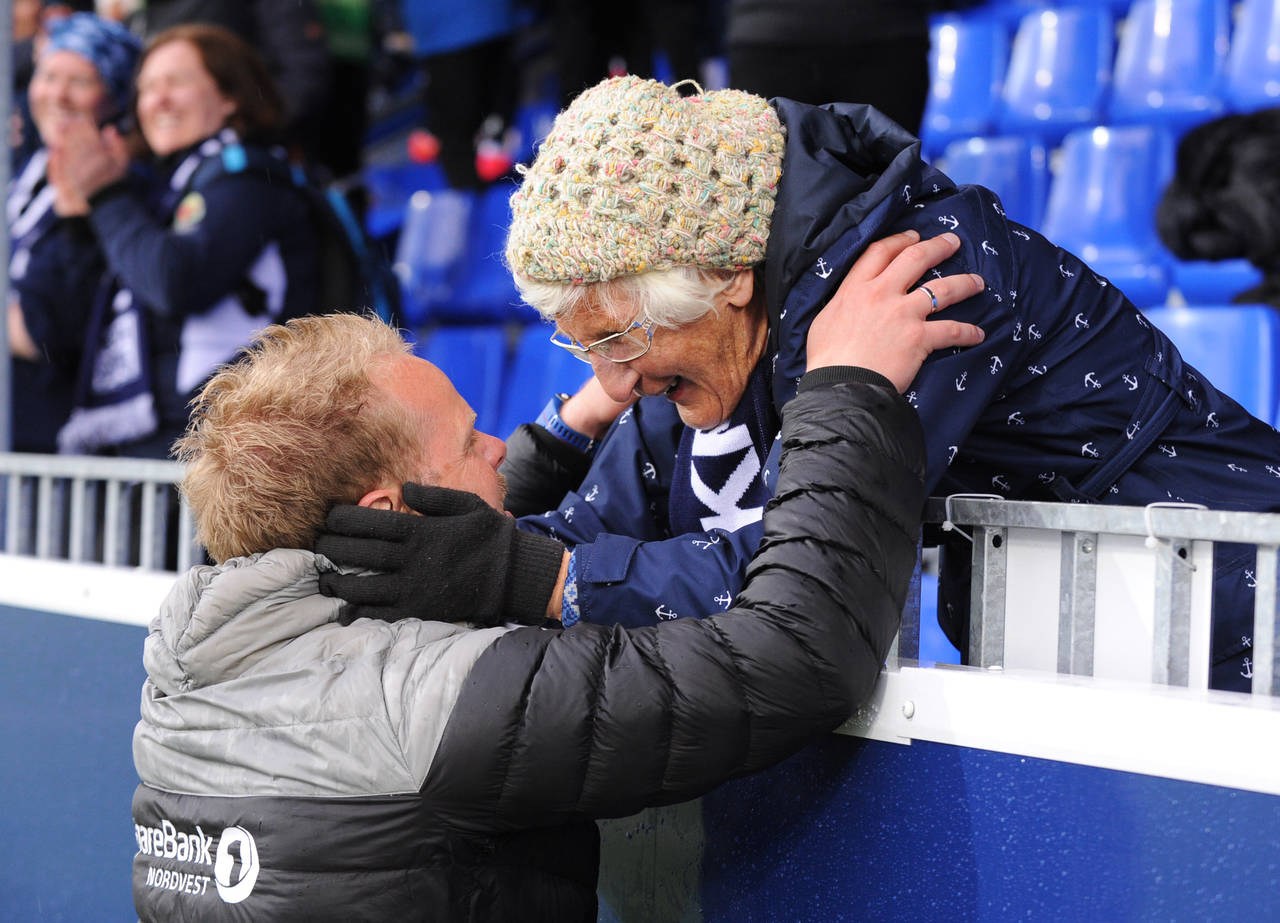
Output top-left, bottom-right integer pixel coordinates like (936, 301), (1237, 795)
(126, 0), (332, 171)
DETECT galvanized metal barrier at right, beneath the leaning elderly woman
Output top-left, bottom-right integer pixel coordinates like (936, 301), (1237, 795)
(921, 495), (1280, 695)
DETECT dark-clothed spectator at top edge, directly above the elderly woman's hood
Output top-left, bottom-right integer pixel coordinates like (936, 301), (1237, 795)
(727, 0), (937, 134)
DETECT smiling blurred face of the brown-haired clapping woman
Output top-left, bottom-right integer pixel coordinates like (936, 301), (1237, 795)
(138, 41), (236, 157)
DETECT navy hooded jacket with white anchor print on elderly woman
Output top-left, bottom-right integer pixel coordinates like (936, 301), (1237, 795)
(513, 100), (1280, 686)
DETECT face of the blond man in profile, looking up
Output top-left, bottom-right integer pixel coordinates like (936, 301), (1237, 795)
(372, 356), (507, 512)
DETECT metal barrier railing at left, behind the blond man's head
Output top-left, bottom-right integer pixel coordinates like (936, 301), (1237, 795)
(0, 452), (204, 572)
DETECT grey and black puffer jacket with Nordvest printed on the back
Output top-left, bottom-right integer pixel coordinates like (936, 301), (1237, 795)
(133, 370), (924, 923)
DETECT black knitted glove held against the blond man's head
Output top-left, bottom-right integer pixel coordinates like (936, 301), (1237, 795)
(316, 483), (564, 625)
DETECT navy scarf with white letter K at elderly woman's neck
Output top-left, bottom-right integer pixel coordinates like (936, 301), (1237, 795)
(669, 360), (780, 535)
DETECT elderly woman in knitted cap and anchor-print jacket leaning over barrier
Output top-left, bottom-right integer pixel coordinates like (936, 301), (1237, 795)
(322, 78), (1280, 687)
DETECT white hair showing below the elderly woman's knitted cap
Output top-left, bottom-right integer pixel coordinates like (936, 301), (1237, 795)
(513, 266), (751, 326)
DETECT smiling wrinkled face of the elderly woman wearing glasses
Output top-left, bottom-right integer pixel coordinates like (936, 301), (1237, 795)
(559, 289), (767, 429)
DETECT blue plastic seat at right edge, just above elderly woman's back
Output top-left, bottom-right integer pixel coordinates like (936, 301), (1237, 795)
(1144, 305), (1280, 425)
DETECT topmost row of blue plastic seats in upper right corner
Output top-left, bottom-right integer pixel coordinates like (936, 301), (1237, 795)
(922, 0), (1280, 155)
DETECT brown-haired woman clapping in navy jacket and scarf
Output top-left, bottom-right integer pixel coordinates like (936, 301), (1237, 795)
(51, 26), (319, 457)
